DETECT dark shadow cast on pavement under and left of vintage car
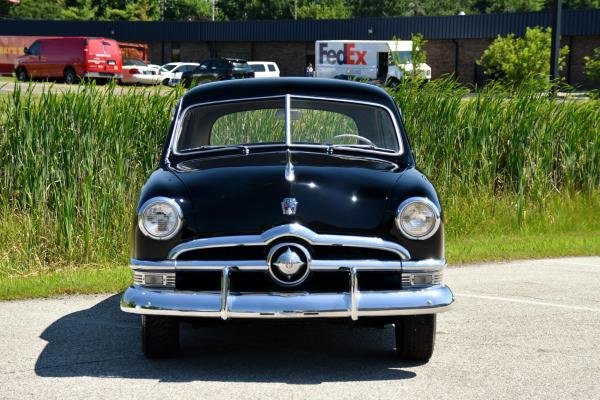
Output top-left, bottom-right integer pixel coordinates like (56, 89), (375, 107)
(35, 295), (416, 384)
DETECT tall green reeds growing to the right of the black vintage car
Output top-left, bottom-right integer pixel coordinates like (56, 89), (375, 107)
(392, 80), (600, 222)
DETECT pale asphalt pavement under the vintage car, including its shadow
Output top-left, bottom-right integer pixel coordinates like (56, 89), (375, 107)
(0, 257), (600, 400)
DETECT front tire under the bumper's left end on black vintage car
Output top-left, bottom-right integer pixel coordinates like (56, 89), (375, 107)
(142, 315), (179, 358)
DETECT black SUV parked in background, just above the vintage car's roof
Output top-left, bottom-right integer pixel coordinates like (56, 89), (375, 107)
(181, 58), (254, 88)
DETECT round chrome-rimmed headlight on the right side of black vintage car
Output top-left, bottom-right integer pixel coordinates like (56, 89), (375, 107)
(396, 197), (440, 240)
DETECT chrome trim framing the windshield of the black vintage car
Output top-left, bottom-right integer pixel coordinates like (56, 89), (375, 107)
(165, 94), (404, 158)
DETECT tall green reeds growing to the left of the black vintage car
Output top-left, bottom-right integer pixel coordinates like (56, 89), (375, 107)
(0, 85), (178, 273)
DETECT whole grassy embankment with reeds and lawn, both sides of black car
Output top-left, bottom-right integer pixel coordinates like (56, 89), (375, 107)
(0, 82), (600, 299)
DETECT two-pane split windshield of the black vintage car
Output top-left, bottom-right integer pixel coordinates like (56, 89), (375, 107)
(175, 97), (400, 153)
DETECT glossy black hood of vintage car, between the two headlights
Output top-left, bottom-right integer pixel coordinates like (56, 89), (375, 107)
(175, 151), (401, 237)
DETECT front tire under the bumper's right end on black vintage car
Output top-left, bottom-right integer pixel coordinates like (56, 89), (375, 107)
(394, 314), (436, 362)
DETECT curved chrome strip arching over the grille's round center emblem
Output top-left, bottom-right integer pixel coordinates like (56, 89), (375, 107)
(168, 224), (410, 260)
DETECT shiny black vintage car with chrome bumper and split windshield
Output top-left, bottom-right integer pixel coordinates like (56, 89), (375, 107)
(121, 78), (454, 361)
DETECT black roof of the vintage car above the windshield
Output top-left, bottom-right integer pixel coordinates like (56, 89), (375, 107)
(181, 77), (397, 110)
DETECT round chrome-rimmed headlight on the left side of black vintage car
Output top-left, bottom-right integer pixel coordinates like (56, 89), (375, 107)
(138, 197), (183, 240)
